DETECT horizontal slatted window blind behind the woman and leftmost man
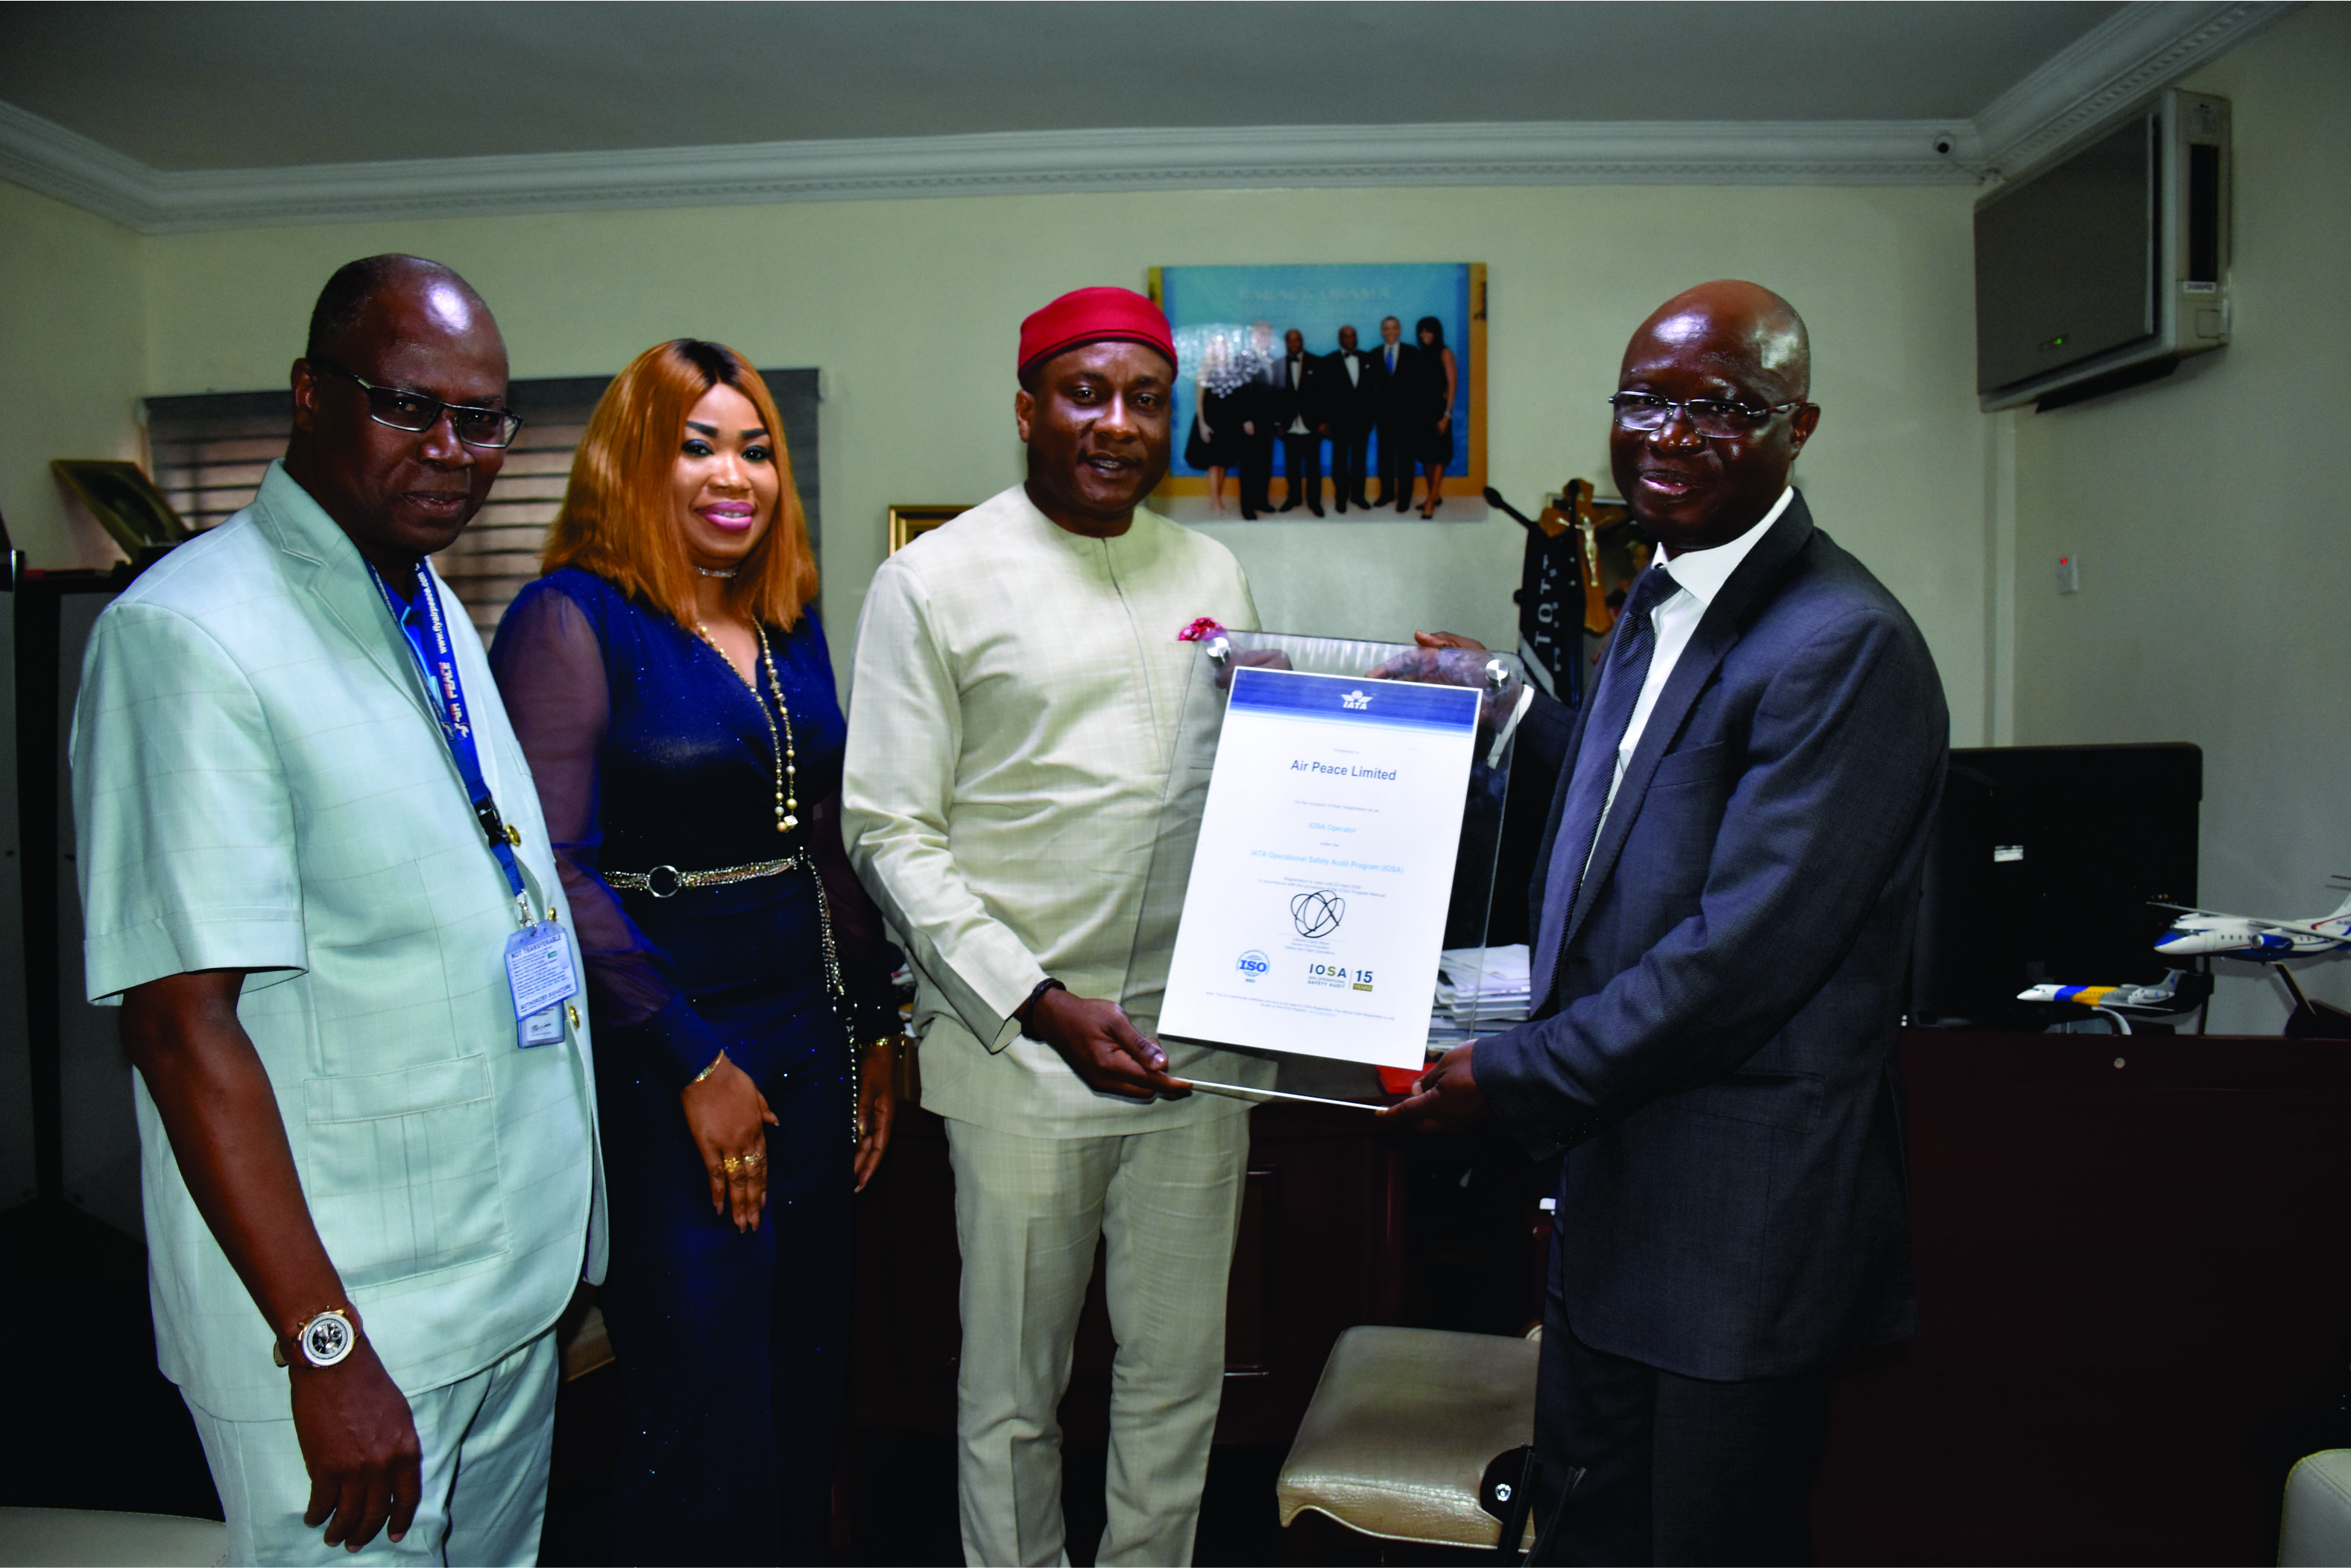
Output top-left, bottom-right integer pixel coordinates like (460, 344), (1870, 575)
(146, 369), (821, 639)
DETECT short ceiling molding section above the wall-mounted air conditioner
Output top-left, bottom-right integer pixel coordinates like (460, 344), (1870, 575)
(1975, 0), (2302, 177)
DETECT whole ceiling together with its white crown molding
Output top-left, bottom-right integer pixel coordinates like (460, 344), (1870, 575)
(0, 0), (2292, 233)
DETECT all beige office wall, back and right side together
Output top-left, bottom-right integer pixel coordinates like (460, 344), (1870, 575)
(0, 7), (2351, 1053)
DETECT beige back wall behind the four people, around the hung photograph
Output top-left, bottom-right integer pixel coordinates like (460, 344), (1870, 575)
(0, 186), (1986, 741)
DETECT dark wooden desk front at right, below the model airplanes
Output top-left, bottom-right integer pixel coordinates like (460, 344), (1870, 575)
(1813, 1032), (2351, 1564)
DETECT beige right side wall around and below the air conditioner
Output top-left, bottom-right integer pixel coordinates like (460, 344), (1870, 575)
(2005, 4), (2351, 1032)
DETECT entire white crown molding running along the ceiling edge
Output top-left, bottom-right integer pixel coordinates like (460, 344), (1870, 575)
(0, 0), (2294, 233)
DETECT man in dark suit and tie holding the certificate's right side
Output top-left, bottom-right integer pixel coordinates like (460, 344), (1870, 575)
(1389, 282), (1949, 1564)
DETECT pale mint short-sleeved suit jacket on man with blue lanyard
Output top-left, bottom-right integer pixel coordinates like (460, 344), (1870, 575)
(73, 463), (605, 1420)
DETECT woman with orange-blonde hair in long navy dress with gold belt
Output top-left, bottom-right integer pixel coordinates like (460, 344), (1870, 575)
(491, 338), (898, 1564)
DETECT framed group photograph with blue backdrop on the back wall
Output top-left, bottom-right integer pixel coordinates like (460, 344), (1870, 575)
(1149, 261), (1486, 522)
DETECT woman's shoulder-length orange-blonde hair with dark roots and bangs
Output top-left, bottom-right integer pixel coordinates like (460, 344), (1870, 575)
(538, 338), (815, 630)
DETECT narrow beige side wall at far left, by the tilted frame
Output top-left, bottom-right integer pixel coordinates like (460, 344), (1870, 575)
(0, 181), (146, 566)
